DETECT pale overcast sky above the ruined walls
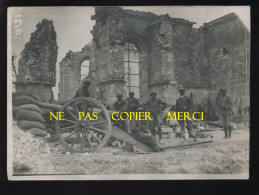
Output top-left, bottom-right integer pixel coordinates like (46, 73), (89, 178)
(8, 6), (250, 99)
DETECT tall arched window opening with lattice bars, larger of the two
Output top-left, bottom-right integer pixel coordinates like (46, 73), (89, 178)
(124, 42), (140, 98)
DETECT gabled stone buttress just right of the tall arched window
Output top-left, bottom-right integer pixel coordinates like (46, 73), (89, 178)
(148, 16), (176, 104)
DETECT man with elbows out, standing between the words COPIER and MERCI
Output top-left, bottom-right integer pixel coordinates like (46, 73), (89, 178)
(144, 92), (167, 144)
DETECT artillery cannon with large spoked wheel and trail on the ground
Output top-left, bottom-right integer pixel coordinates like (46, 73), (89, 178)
(13, 92), (153, 153)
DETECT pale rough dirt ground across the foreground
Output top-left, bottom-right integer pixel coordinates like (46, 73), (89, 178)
(14, 124), (249, 175)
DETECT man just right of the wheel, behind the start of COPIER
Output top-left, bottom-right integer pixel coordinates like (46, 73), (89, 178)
(113, 93), (130, 133)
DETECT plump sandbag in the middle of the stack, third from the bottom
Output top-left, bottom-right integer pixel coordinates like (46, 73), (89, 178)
(15, 109), (45, 123)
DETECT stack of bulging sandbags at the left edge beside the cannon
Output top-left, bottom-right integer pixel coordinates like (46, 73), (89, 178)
(13, 93), (48, 137)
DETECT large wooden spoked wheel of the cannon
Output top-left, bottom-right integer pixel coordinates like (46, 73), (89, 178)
(55, 97), (111, 153)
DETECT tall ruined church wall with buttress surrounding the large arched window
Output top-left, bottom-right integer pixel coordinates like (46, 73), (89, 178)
(92, 8), (219, 105)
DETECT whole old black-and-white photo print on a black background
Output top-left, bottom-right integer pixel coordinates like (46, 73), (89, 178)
(7, 6), (250, 180)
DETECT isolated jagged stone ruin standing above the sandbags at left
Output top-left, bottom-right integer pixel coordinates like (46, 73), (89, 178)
(15, 19), (58, 102)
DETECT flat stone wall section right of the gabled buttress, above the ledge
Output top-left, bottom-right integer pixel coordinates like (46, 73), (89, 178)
(172, 20), (207, 85)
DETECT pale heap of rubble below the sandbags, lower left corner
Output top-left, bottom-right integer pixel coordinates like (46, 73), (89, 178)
(13, 121), (52, 173)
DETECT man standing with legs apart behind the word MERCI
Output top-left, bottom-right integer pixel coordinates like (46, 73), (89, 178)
(175, 87), (197, 142)
